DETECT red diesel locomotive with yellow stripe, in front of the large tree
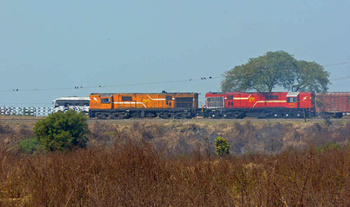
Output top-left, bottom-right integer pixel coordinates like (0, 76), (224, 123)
(203, 92), (315, 118)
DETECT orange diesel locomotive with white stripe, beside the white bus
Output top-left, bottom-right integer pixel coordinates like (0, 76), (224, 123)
(89, 92), (198, 119)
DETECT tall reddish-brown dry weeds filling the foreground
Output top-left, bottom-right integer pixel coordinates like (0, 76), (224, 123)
(0, 140), (350, 206)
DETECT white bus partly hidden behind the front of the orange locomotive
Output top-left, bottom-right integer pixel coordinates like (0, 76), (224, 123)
(52, 96), (90, 115)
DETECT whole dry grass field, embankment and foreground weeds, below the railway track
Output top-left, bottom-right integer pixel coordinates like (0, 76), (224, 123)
(0, 118), (350, 206)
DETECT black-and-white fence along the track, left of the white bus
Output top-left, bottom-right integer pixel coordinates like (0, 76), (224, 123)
(0, 106), (53, 116)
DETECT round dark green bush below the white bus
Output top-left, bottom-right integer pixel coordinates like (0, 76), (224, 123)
(34, 110), (89, 151)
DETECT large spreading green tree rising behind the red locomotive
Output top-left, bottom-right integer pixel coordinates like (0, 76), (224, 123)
(221, 51), (330, 92)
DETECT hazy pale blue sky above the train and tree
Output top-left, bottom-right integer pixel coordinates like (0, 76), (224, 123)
(0, 0), (350, 106)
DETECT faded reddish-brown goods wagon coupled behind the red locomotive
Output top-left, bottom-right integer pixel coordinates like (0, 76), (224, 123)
(316, 92), (350, 118)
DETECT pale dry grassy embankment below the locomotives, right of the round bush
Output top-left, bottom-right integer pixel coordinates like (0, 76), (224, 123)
(86, 121), (350, 155)
